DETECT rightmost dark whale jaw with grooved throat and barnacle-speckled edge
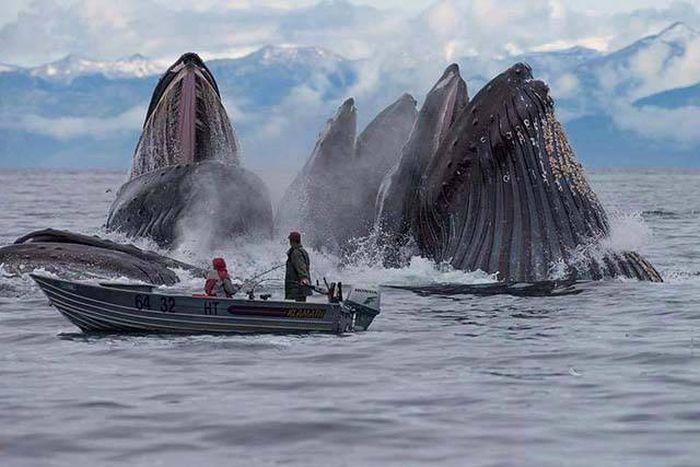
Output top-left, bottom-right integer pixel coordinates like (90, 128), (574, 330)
(415, 63), (661, 282)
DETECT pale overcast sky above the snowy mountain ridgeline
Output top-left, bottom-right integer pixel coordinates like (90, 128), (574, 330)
(0, 0), (700, 66)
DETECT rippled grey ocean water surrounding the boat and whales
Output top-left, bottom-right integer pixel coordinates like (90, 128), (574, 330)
(0, 171), (700, 466)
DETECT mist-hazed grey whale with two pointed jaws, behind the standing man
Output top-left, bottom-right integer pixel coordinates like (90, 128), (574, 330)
(275, 94), (417, 252)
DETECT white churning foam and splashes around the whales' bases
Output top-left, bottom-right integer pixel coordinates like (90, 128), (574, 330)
(0, 199), (700, 296)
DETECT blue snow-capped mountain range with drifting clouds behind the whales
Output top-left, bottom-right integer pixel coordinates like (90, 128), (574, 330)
(0, 23), (700, 170)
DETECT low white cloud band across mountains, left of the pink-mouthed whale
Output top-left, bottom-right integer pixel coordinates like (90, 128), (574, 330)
(0, 106), (146, 141)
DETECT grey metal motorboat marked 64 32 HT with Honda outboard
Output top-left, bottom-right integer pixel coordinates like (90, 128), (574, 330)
(30, 274), (379, 334)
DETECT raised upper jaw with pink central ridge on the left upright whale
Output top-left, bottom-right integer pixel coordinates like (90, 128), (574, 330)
(131, 53), (238, 178)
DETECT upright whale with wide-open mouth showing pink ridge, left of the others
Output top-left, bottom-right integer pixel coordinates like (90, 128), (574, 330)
(106, 53), (272, 247)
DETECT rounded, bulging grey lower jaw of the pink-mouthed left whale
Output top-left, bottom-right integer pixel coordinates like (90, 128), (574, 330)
(107, 161), (272, 247)
